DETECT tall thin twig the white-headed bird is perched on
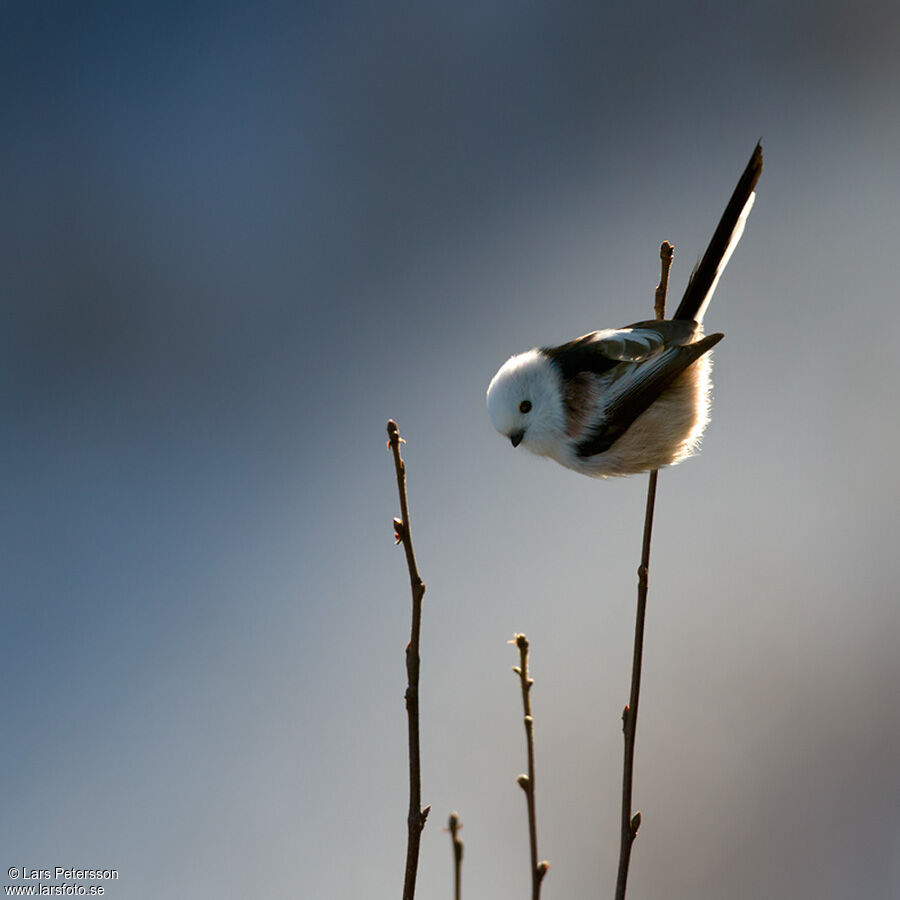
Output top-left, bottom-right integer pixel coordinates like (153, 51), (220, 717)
(616, 241), (675, 900)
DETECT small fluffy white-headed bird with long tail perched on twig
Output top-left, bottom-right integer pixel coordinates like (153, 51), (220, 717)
(487, 143), (763, 478)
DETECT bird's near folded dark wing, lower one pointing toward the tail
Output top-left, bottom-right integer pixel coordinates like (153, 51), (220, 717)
(576, 333), (725, 457)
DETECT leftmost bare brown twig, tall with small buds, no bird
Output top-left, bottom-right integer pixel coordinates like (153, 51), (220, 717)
(387, 419), (431, 900)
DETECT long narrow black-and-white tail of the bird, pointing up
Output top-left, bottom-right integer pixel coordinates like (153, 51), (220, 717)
(673, 144), (762, 322)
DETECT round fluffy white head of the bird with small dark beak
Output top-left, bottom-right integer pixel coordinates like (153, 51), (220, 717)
(487, 350), (565, 456)
